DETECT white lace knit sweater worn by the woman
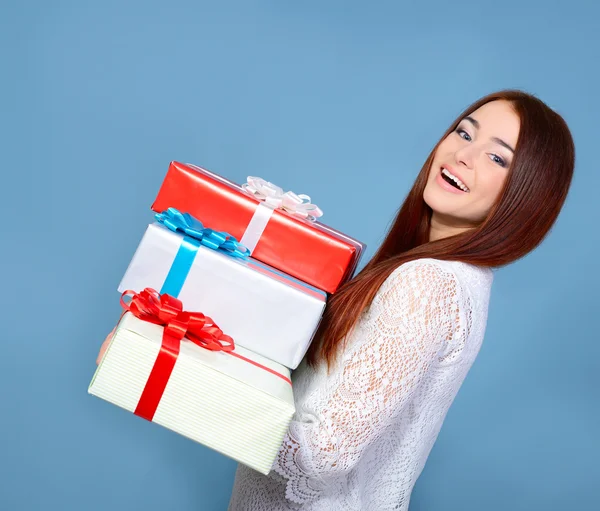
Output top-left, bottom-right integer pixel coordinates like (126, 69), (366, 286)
(229, 259), (493, 511)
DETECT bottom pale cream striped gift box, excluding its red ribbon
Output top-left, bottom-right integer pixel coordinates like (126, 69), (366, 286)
(88, 312), (295, 474)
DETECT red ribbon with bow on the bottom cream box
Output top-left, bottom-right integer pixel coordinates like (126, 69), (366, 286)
(121, 288), (292, 421)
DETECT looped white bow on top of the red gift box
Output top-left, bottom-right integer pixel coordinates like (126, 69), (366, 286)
(242, 176), (323, 222)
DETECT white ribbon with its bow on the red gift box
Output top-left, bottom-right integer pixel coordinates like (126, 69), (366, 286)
(240, 176), (323, 253)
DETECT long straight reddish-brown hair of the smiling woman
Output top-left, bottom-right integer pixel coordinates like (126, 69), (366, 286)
(307, 90), (575, 367)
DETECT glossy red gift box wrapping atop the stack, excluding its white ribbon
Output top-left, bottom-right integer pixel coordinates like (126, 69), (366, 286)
(152, 162), (365, 293)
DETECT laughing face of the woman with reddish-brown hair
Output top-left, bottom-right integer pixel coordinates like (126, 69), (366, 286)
(423, 100), (521, 231)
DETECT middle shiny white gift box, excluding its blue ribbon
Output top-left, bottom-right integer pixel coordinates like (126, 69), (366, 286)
(119, 223), (326, 369)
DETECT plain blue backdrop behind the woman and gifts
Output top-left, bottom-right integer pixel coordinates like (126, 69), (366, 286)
(0, 0), (600, 511)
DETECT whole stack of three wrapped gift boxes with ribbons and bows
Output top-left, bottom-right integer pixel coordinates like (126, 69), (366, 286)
(89, 162), (364, 474)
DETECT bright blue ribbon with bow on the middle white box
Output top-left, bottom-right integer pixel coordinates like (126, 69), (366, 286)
(155, 208), (250, 298)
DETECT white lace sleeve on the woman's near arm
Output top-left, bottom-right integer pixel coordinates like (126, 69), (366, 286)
(273, 260), (460, 504)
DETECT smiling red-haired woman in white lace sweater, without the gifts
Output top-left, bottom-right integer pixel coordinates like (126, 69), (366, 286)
(229, 91), (575, 511)
